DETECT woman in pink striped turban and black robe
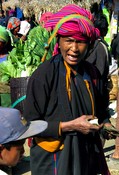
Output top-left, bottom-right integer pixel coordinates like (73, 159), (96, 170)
(24, 5), (111, 175)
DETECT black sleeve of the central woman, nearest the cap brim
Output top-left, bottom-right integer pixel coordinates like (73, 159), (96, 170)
(24, 63), (60, 138)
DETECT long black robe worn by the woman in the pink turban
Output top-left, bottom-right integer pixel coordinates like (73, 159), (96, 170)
(24, 55), (108, 175)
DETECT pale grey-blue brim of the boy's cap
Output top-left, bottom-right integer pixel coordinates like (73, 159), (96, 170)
(16, 120), (48, 140)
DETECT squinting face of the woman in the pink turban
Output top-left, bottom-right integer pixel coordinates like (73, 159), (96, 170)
(59, 37), (88, 66)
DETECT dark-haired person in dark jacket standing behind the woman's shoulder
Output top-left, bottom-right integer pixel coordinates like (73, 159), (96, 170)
(86, 13), (111, 146)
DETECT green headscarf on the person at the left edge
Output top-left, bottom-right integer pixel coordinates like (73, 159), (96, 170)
(0, 25), (9, 43)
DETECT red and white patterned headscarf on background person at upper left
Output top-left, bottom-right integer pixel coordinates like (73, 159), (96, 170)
(7, 17), (21, 30)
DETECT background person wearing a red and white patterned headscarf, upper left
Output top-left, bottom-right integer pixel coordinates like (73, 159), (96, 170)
(7, 17), (21, 45)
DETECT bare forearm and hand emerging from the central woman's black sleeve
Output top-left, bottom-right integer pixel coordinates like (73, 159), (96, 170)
(61, 115), (103, 134)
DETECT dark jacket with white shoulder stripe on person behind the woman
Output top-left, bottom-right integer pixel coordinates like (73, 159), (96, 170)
(86, 38), (111, 116)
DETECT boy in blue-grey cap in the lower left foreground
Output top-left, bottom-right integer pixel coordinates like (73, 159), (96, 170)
(0, 107), (47, 175)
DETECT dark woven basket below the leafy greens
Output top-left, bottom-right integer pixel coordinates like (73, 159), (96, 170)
(10, 77), (29, 113)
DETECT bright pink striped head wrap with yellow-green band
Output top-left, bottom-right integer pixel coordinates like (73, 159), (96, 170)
(42, 4), (100, 60)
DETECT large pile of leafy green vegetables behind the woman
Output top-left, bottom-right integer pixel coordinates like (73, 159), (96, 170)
(0, 26), (56, 82)
